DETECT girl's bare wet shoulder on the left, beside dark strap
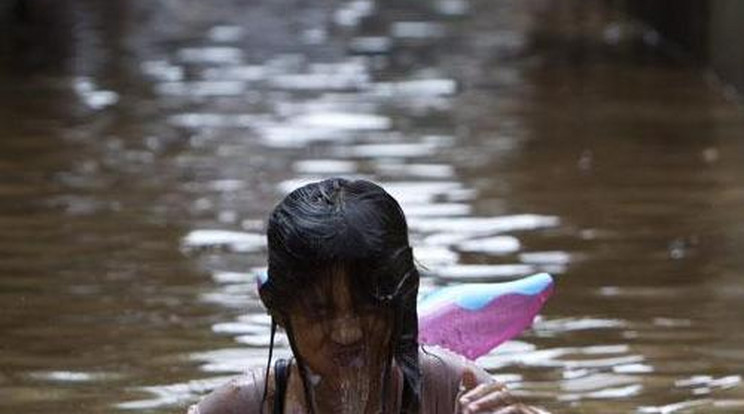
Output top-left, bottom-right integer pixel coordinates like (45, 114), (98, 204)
(188, 370), (265, 414)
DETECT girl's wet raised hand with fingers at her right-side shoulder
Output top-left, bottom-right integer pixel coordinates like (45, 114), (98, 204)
(457, 371), (546, 414)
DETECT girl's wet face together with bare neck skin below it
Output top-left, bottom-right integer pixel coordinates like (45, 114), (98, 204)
(286, 268), (392, 413)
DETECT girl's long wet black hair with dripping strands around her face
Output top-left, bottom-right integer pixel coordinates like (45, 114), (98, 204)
(260, 178), (421, 414)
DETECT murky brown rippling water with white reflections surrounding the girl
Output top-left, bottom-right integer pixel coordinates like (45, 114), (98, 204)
(0, 0), (744, 414)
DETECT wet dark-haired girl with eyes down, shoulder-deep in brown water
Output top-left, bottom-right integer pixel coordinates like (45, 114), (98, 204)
(189, 178), (544, 414)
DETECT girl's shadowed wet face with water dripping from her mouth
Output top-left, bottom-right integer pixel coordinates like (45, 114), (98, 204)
(289, 268), (392, 378)
